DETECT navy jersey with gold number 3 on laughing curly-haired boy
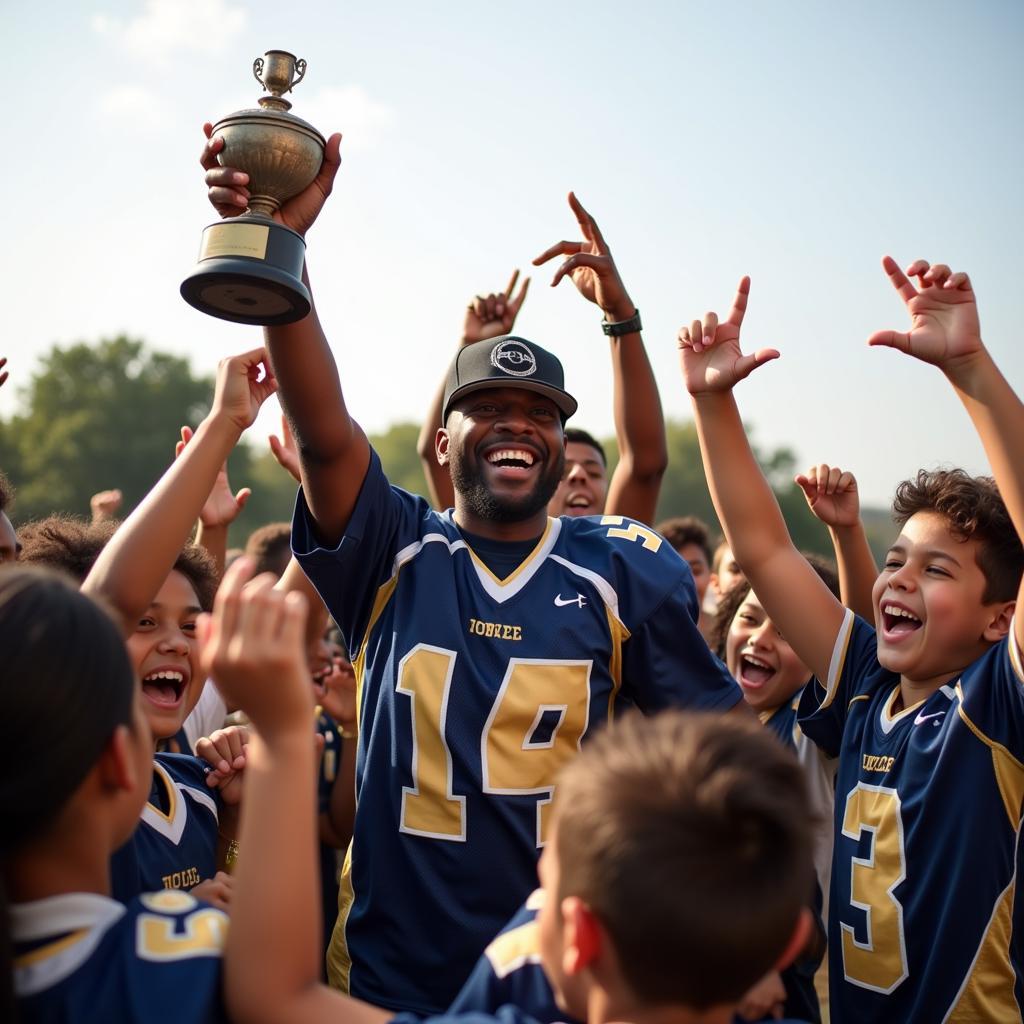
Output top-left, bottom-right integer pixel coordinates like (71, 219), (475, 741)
(800, 611), (1024, 1024)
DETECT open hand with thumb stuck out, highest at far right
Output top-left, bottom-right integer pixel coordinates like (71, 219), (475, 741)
(867, 256), (984, 367)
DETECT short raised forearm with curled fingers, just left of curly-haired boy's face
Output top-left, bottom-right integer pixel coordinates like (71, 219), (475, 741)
(795, 463), (879, 623)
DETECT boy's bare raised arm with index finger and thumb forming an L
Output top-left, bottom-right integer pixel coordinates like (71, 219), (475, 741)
(679, 278), (844, 679)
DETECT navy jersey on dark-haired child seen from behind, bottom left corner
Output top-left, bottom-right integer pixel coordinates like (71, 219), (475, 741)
(11, 892), (227, 1024)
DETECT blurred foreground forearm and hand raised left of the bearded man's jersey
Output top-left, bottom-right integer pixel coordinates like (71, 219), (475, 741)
(201, 558), (392, 1024)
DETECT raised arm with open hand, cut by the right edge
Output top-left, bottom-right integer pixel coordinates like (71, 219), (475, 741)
(867, 256), (1024, 648)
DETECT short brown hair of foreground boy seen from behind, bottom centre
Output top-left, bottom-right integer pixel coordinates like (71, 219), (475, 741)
(555, 711), (813, 1010)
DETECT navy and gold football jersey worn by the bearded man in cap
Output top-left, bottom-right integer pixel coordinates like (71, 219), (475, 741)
(292, 454), (741, 1014)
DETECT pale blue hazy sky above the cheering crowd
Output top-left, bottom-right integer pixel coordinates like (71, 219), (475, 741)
(0, 0), (1024, 503)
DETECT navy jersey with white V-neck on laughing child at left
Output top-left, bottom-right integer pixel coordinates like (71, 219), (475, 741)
(111, 754), (220, 903)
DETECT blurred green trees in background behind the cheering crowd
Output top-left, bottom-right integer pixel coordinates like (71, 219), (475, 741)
(0, 336), (888, 555)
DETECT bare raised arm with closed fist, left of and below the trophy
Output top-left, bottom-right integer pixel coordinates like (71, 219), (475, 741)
(82, 356), (276, 635)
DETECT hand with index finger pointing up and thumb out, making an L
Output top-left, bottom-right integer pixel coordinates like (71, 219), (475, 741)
(679, 278), (778, 395)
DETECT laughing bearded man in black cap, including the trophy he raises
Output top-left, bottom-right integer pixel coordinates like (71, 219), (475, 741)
(193, 51), (741, 1016)
